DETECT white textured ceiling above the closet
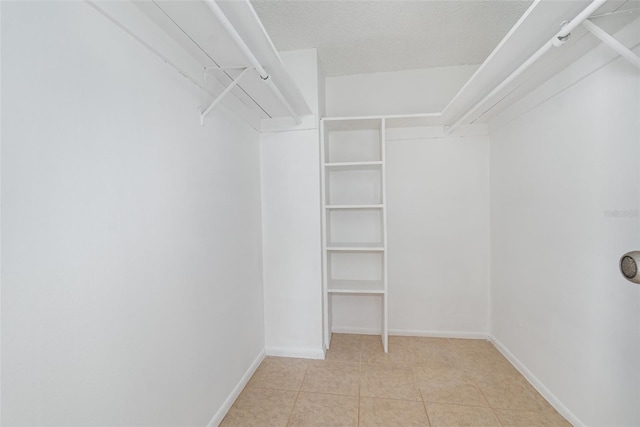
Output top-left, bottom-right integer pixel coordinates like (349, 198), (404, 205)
(251, 0), (531, 76)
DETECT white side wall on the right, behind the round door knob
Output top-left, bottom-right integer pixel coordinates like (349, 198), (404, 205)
(490, 44), (640, 425)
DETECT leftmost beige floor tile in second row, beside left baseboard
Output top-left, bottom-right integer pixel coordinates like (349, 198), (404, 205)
(248, 357), (309, 391)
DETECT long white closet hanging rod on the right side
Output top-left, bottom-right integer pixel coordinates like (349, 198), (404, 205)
(445, 0), (607, 134)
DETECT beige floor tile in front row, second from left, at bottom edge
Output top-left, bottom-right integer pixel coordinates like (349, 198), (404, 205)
(289, 392), (358, 426)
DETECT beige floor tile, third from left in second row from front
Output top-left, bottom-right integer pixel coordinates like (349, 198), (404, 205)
(360, 363), (422, 401)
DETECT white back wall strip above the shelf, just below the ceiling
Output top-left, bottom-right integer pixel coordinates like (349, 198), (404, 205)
(326, 65), (478, 116)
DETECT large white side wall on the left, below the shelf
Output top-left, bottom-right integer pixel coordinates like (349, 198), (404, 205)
(2, 2), (264, 425)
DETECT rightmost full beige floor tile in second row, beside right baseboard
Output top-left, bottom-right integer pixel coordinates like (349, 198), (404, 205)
(476, 374), (550, 411)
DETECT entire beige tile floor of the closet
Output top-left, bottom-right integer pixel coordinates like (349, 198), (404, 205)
(221, 334), (570, 427)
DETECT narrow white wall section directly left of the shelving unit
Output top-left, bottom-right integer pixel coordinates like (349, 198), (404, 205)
(260, 49), (324, 358)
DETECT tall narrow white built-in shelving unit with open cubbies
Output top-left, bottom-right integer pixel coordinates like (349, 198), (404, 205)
(321, 118), (388, 352)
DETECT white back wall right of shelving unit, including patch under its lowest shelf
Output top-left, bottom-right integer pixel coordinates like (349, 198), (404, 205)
(333, 136), (489, 336)
